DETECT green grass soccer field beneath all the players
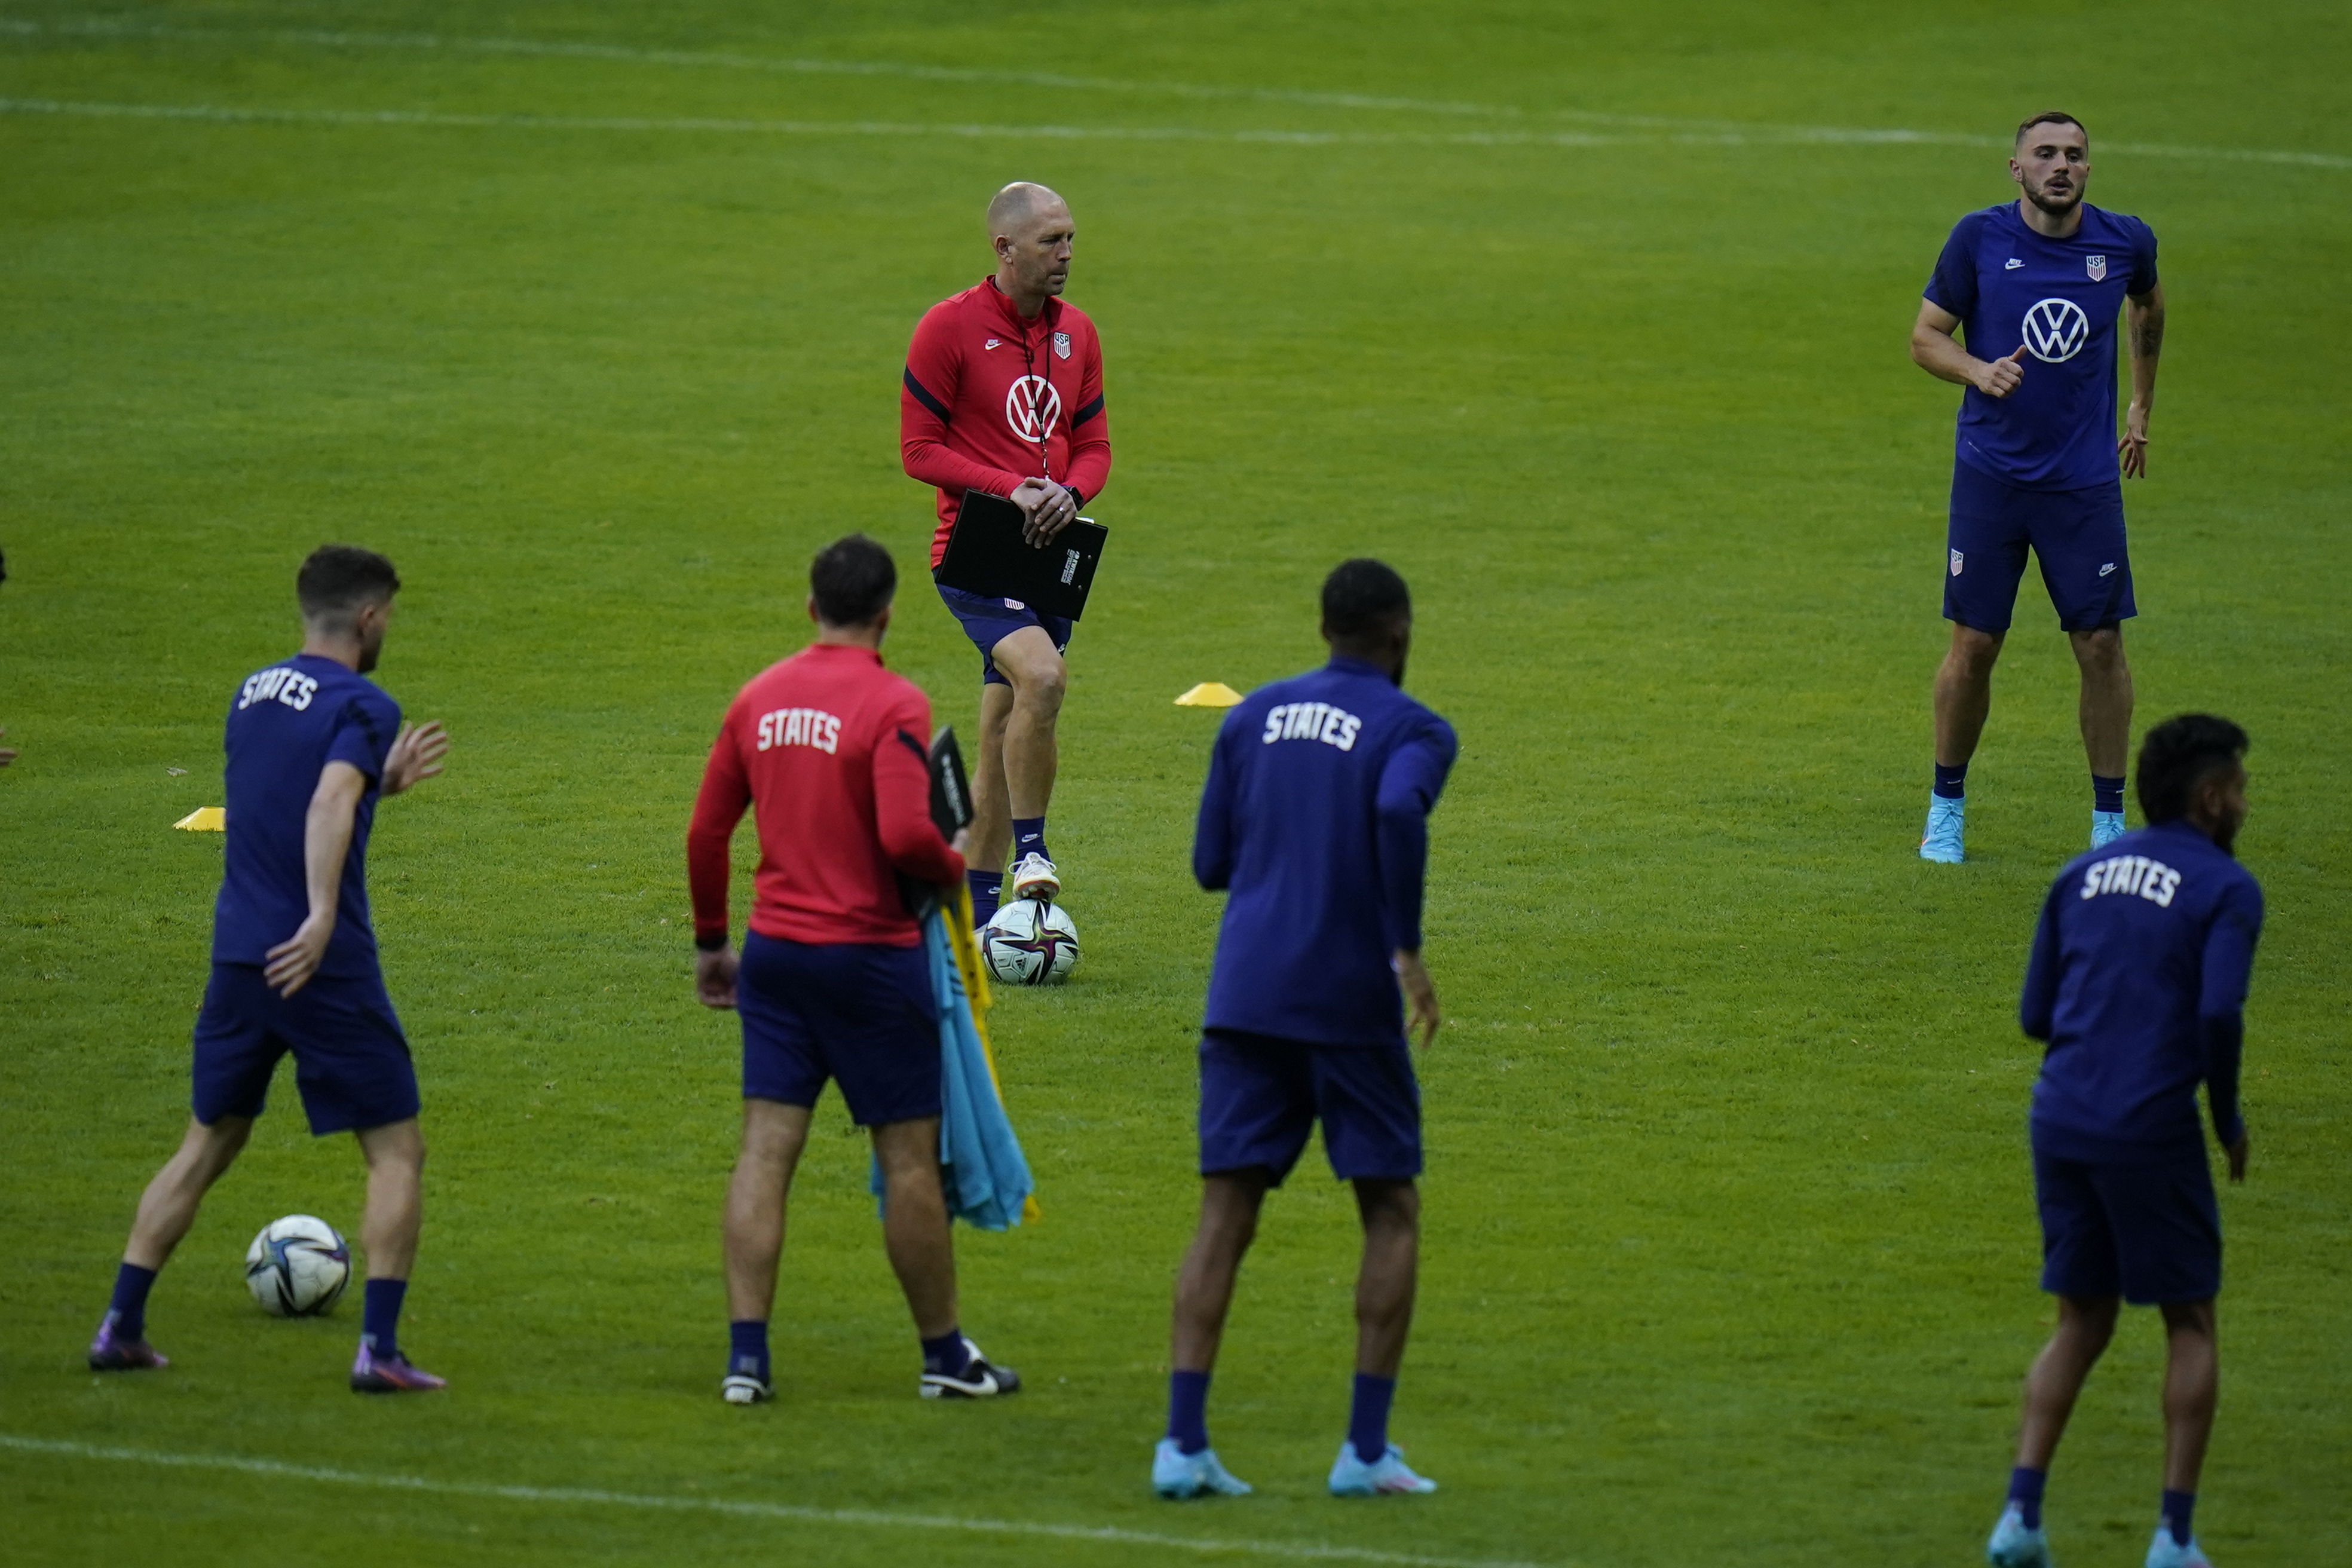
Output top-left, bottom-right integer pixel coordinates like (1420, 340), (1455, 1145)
(0, 0), (2352, 1568)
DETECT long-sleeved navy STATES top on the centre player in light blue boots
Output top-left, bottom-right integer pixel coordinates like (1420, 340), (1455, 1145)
(1193, 659), (1453, 1046)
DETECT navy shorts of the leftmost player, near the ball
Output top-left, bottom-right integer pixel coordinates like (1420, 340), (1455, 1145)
(191, 964), (416, 1138)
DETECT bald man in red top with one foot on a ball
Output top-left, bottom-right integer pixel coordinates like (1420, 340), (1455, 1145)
(899, 181), (1110, 921)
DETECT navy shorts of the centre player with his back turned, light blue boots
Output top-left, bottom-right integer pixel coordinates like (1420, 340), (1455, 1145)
(1199, 1030), (1420, 1187)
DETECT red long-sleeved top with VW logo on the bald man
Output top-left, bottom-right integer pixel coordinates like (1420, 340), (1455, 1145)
(899, 277), (1110, 569)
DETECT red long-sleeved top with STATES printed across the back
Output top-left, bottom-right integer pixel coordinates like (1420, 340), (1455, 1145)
(687, 642), (964, 947)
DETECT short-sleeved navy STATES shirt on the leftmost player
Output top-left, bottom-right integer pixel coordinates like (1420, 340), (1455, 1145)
(212, 654), (400, 976)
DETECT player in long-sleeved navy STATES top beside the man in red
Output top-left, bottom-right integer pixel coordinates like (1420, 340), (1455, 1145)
(1153, 559), (1453, 1497)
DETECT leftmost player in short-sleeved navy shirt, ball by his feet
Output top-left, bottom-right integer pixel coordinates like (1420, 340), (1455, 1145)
(90, 546), (449, 1394)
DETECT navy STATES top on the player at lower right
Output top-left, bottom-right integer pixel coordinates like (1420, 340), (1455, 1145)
(2018, 823), (2262, 1161)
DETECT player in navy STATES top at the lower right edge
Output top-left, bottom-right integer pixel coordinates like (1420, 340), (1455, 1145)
(1985, 712), (2262, 1568)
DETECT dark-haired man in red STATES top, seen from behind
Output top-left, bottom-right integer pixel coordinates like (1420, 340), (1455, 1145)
(687, 534), (1021, 1404)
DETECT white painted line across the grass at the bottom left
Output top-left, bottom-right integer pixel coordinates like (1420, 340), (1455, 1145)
(0, 1432), (1571, 1568)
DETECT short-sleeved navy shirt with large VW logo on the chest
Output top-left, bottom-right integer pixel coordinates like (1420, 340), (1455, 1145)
(1927, 202), (2157, 489)
